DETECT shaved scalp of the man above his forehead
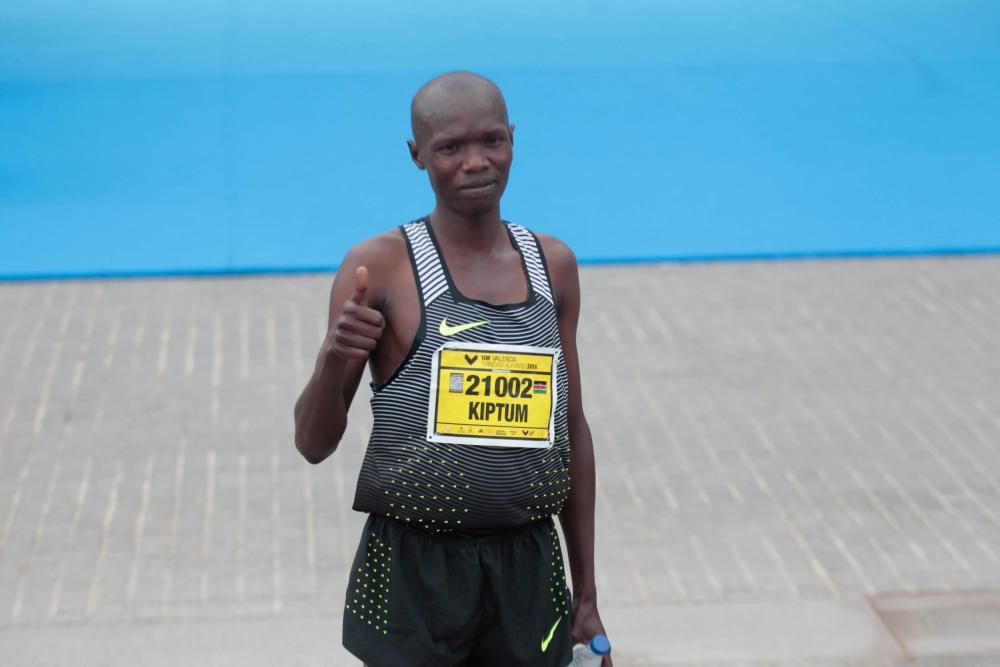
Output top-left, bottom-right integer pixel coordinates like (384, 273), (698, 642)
(410, 72), (508, 144)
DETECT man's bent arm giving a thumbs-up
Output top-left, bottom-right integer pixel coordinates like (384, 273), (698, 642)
(295, 244), (385, 464)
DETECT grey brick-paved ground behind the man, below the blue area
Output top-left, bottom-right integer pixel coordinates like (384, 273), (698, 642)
(0, 257), (1000, 666)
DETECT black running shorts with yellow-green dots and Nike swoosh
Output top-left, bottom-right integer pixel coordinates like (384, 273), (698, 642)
(344, 515), (572, 667)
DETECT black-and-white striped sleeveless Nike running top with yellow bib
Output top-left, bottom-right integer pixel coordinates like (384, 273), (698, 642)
(354, 219), (570, 532)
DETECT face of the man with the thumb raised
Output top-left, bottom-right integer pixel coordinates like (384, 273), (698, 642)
(410, 93), (513, 216)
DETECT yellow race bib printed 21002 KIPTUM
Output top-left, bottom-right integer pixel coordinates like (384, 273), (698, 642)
(427, 342), (559, 448)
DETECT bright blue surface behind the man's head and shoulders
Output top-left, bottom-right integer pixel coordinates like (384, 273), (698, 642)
(0, 0), (1000, 278)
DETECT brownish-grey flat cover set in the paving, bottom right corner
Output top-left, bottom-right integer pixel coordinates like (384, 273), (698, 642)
(869, 592), (1000, 658)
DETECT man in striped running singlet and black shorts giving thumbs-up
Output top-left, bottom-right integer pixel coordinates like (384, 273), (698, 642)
(295, 72), (611, 667)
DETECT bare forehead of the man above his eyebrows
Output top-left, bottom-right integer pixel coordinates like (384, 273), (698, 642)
(419, 90), (507, 139)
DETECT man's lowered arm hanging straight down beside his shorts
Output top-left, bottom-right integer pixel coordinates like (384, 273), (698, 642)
(542, 237), (612, 667)
